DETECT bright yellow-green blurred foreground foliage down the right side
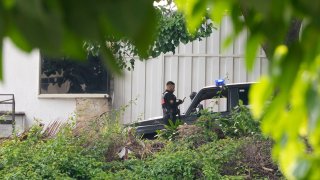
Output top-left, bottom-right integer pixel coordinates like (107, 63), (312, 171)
(176, 0), (320, 179)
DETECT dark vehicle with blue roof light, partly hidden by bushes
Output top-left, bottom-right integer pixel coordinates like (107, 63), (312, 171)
(132, 83), (253, 135)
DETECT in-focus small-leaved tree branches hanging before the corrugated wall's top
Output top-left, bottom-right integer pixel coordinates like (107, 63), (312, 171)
(84, 4), (214, 71)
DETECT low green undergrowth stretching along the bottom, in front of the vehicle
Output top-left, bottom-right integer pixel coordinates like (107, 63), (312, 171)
(0, 106), (281, 179)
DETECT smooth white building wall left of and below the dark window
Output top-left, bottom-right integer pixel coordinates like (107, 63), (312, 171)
(0, 39), (76, 125)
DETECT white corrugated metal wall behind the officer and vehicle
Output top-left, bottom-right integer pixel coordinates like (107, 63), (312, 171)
(113, 17), (268, 123)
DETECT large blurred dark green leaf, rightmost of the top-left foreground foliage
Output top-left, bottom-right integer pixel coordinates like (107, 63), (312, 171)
(103, 0), (157, 57)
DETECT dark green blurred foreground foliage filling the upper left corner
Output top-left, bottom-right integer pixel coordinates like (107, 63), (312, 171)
(0, 0), (157, 77)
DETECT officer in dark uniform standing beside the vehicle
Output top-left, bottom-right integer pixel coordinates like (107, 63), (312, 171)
(161, 81), (183, 124)
